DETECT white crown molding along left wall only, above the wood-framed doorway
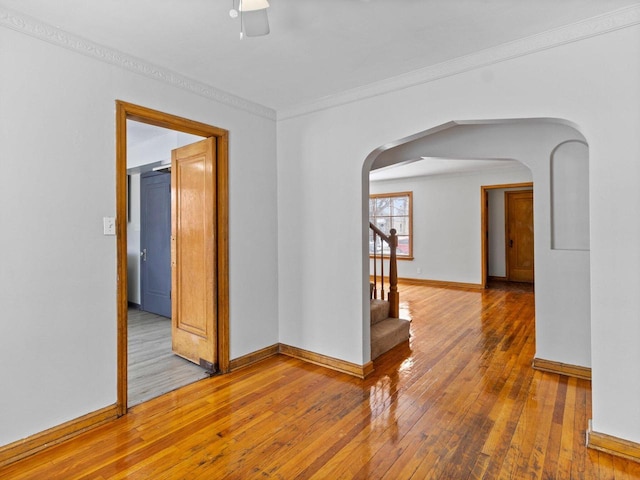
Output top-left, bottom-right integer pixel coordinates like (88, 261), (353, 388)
(0, 6), (276, 120)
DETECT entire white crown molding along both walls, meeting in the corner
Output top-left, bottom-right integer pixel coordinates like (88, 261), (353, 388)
(0, 6), (640, 120)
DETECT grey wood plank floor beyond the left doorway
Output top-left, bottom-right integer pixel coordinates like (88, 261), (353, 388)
(127, 309), (209, 407)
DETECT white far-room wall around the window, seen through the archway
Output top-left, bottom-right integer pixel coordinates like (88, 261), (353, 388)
(369, 166), (531, 284)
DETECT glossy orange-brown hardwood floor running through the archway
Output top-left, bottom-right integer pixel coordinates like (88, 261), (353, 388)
(0, 285), (640, 480)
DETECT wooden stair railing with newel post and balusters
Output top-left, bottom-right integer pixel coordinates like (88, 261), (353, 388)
(369, 222), (400, 318)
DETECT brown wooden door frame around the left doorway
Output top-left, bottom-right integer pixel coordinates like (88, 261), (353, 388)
(116, 100), (229, 416)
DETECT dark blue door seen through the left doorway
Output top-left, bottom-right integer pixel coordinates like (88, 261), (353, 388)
(140, 172), (171, 317)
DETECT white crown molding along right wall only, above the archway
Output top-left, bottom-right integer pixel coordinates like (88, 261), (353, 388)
(278, 5), (640, 120)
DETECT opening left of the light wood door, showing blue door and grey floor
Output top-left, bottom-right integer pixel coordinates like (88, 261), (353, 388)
(127, 126), (210, 407)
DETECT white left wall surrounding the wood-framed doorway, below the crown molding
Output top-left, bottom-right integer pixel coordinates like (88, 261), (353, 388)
(0, 28), (278, 445)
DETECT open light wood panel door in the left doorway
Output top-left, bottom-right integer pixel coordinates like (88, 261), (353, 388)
(171, 138), (217, 369)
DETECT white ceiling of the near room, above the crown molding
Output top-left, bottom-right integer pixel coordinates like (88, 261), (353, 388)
(0, 0), (640, 110)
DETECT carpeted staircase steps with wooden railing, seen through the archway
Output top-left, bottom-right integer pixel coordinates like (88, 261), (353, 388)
(369, 223), (410, 360)
